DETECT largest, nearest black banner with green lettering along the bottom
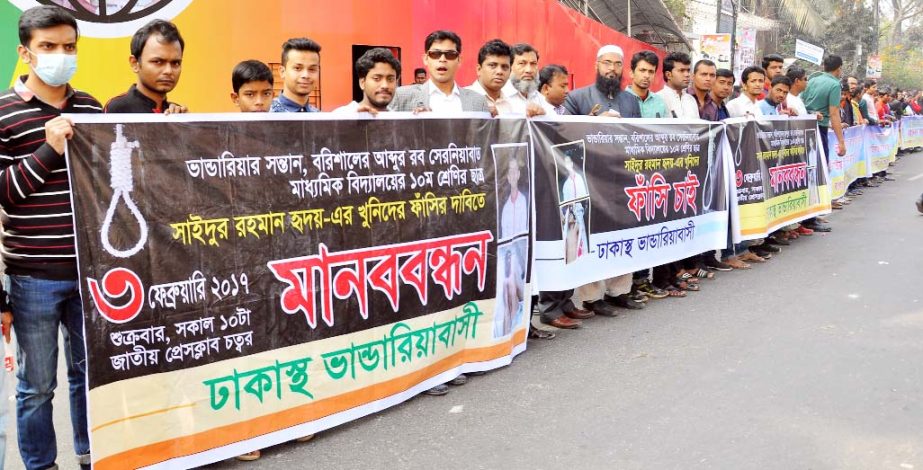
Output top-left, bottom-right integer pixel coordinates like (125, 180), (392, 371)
(68, 114), (532, 469)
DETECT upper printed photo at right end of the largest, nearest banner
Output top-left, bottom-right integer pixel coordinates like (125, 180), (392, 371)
(490, 143), (532, 241)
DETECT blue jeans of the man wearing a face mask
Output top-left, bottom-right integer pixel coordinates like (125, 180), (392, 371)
(9, 276), (90, 470)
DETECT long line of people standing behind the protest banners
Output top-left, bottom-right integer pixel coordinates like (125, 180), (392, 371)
(0, 6), (923, 469)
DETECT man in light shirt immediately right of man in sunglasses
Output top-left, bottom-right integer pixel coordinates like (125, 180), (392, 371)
(465, 39), (513, 114)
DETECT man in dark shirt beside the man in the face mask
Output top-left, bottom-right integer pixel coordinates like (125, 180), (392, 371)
(105, 20), (187, 114)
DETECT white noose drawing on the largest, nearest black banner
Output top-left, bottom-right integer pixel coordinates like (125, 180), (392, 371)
(101, 124), (147, 258)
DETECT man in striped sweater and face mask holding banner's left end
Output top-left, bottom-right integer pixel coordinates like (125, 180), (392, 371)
(0, 6), (102, 469)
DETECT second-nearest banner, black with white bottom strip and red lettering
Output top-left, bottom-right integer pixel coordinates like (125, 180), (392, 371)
(530, 116), (728, 291)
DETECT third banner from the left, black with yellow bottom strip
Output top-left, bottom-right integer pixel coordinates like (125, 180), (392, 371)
(725, 116), (832, 243)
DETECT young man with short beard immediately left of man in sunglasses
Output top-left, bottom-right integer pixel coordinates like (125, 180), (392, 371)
(333, 47), (401, 116)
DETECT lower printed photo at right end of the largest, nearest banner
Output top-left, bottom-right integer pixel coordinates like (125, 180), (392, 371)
(494, 238), (528, 339)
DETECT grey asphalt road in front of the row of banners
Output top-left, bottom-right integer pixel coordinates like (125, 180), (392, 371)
(6, 154), (923, 470)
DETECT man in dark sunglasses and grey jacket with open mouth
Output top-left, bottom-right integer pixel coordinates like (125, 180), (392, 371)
(390, 31), (490, 113)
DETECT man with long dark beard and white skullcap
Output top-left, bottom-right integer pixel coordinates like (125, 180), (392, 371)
(564, 44), (641, 118)
